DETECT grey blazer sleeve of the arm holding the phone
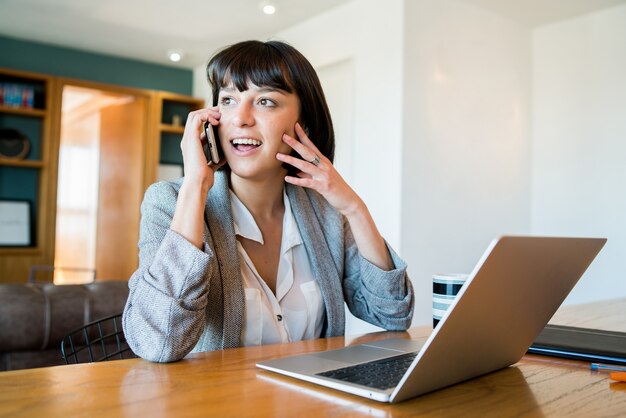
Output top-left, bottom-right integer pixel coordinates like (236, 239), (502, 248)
(122, 182), (215, 362)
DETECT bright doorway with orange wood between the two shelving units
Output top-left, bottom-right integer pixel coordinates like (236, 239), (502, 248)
(54, 84), (147, 284)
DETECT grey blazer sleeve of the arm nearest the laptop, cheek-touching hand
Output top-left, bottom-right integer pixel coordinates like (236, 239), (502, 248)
(343, 219), (414, 331)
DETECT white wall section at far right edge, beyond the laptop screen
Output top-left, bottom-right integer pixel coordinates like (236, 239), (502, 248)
(531, 2), (626, 303)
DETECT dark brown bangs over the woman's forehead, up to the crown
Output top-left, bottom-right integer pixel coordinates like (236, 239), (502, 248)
(207, 42), (293, 97)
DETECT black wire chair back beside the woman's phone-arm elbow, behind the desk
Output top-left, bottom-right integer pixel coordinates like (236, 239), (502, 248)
(61, 313), (137, 364)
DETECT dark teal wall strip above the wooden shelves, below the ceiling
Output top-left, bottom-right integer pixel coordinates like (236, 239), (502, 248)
(0, 36), (192, 95)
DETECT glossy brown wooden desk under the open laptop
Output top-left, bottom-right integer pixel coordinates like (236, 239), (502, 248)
(0, 299), (626, 418)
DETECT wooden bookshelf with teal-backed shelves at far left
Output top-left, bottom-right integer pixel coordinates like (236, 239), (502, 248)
(0, 69), (54, 282)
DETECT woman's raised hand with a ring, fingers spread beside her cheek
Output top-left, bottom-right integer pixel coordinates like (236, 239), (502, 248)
(276, 123), (363, 216)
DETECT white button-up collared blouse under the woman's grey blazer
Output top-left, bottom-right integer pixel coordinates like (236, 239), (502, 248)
(230, 190), (325, 346)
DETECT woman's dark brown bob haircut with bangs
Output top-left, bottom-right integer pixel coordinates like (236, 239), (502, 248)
(207, 41), (335, 161)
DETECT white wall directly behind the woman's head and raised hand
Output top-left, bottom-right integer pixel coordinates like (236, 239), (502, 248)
(273, 0), (403, 334)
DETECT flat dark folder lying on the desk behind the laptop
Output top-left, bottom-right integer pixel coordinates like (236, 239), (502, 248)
(528, 324), (626, 364)
